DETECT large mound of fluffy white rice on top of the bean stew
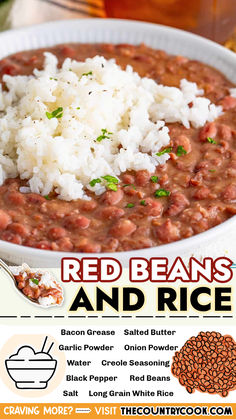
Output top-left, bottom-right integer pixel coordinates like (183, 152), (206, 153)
(0, 53), (222, 201)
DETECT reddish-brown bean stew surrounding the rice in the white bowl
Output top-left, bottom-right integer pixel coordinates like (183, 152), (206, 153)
(0, 44), (236, 252)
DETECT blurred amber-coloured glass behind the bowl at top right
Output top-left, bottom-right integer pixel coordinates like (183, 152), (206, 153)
(105, 0), (236, 43)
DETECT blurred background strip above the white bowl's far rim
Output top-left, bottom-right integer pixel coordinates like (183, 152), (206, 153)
(0, 0), (236, 50)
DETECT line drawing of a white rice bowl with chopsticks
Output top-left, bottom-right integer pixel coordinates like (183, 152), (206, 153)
(5, 338), (57, 390)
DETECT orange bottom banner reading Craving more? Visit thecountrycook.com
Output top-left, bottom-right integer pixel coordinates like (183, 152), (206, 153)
(0, 403), (236, 419)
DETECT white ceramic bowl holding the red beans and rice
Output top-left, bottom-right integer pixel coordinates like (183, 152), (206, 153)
(0, 19), (236, 268)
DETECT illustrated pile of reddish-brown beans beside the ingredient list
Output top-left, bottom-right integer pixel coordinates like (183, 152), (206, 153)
(171, 332), (236, 397)
